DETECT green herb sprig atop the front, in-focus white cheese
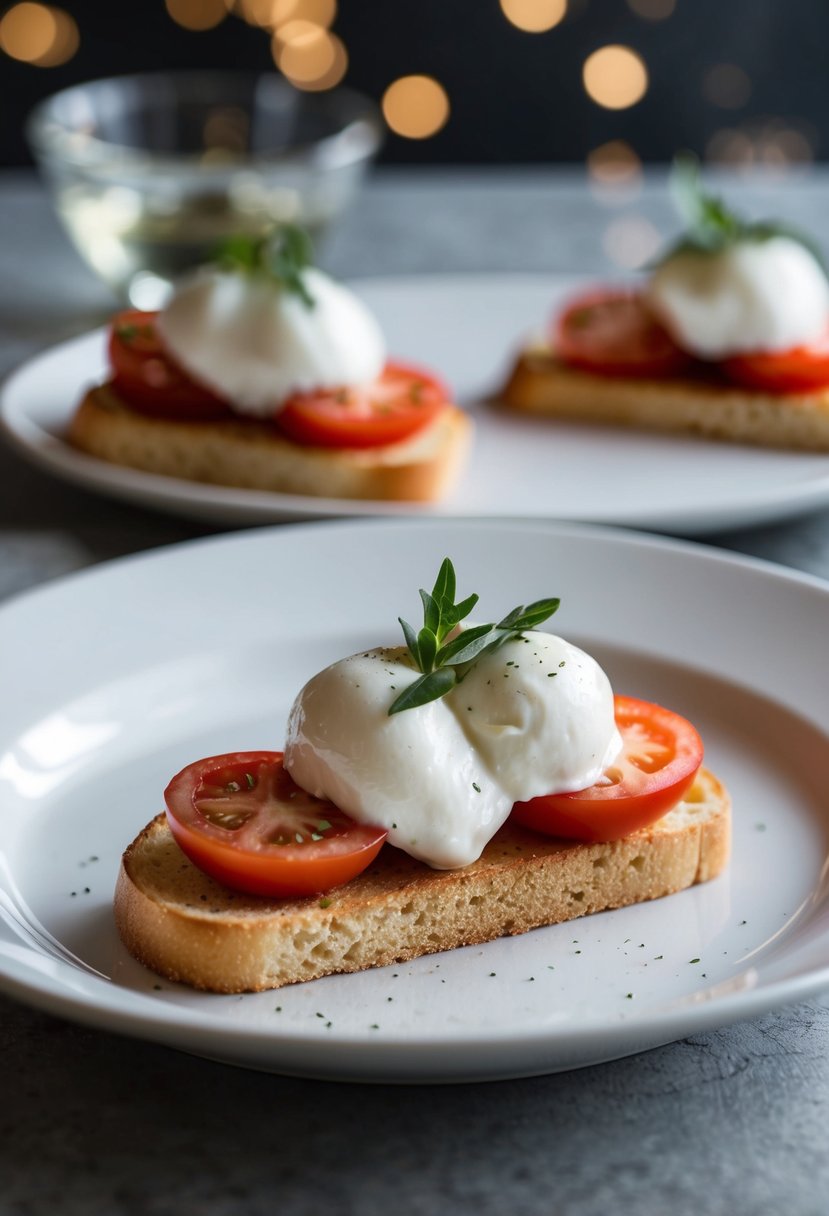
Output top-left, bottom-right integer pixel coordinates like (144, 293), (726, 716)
(389, 558), (560, 714)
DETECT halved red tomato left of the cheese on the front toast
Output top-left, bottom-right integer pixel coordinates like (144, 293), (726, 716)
(164, 751), (387, 899)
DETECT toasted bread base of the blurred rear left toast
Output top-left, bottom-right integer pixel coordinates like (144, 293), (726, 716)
(69, 385), (472, 502)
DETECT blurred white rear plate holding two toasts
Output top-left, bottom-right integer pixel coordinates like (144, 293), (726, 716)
(0, 275), (829, 534)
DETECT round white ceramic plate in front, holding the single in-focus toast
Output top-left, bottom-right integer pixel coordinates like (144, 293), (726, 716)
(0, 520), (829, 1081)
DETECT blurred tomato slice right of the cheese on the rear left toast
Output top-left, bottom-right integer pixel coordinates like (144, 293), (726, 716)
(277, 362), (450, 447)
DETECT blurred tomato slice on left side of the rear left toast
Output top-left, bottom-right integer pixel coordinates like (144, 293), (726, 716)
(109, 309), (233, 420)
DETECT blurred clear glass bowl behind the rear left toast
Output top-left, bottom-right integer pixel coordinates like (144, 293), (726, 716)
(27, 72), (383, 308)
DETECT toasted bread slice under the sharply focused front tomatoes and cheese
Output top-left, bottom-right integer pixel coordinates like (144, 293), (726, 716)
(114, 770), (731, 992)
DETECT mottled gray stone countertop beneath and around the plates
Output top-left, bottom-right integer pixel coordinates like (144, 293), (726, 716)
(0, 170), (829, 1216)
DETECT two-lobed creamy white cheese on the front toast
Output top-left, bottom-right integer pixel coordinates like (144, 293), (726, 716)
(284, 632), (621, 869)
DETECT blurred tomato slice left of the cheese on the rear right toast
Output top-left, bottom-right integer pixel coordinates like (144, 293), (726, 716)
(553, 288), (692, 377)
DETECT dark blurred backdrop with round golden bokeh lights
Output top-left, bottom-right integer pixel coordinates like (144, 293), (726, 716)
(0, 0), (829, 171)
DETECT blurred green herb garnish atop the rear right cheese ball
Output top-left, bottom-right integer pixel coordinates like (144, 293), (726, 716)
(656, 152), (827, 272)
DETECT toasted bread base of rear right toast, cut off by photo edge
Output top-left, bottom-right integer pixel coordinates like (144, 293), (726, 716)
(500, 347), (829, 451)
